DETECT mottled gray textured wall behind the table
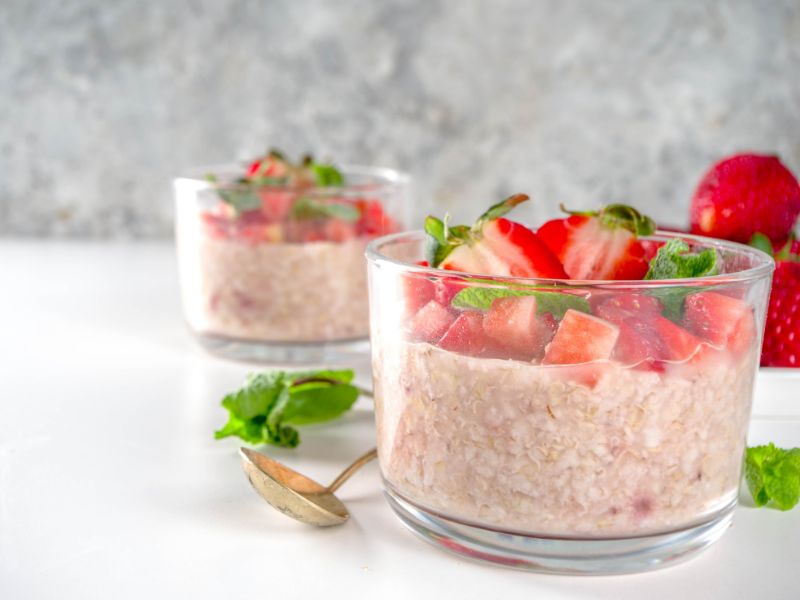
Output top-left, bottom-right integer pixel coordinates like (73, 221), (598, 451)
(0, 0), (800, 237)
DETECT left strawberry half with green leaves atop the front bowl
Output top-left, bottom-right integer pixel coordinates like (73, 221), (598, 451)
(425, 194), (567, 279)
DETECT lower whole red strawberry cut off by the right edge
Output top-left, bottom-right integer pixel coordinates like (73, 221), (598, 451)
(761, 240), (800, 367)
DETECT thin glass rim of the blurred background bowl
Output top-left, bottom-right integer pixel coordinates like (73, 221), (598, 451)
(174, 163), (411, 195)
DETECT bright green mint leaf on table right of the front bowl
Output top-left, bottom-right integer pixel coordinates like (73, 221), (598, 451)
(744, 443), (800, 510)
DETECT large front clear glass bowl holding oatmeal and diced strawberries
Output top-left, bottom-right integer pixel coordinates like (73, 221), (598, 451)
(367, 232), (773, 574)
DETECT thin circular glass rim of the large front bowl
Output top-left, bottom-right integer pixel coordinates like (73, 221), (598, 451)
(366, 229), (775, 289)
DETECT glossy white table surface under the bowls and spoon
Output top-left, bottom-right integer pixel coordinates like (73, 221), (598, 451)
(0, 240), (800, 600)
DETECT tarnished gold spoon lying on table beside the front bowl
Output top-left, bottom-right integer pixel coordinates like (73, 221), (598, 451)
(239, 448), (378, 527)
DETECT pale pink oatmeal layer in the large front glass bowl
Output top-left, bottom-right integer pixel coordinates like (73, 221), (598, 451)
(374, 341), (756, 537)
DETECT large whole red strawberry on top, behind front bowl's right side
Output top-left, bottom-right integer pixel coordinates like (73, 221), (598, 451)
(690, 154), (800, 244)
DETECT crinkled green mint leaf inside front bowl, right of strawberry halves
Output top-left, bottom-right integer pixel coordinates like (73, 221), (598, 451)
(644, 238), (719, 321)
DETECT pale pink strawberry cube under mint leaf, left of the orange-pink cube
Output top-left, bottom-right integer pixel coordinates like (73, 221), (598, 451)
(483, 296), (555, 361)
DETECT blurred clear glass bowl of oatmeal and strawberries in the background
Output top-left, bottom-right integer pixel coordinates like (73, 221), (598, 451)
(174, 162), (409, 363)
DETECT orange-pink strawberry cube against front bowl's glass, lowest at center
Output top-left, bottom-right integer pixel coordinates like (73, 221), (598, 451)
(542, 309), (619, 365)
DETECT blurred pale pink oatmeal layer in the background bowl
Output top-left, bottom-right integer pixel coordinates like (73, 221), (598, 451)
(180, 231), (369, 341)
